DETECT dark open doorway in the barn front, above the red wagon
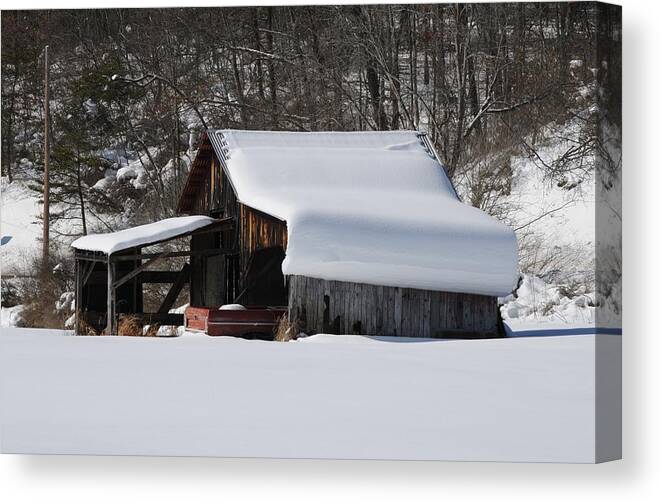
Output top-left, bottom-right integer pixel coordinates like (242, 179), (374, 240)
(235, 246), (287, 306)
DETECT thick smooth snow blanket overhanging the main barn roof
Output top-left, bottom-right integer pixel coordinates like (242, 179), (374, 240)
(208, 130), (517, 295)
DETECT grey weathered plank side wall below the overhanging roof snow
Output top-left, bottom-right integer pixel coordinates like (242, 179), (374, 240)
(289, 276), (500, 337)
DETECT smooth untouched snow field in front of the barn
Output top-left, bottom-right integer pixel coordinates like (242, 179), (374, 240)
(0, 328), (621, 462)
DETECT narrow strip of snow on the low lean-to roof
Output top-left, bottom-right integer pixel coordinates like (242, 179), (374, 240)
(71, 215), (216, 255)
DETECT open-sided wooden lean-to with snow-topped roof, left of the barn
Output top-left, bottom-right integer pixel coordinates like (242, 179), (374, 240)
(71, 215), (234, 334)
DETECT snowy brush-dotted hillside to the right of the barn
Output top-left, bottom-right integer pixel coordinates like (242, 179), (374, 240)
(476, 112), (600, 326)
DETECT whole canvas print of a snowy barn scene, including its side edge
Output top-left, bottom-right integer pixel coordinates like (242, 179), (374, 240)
(0, 2), (622, 463)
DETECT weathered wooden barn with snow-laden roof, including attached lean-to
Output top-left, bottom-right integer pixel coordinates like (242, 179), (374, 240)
(74, 130), (517, 337)
